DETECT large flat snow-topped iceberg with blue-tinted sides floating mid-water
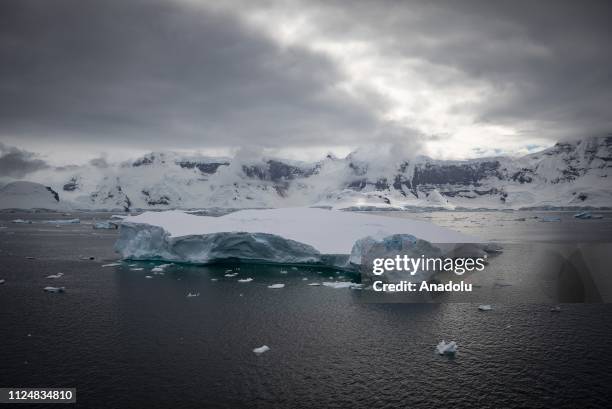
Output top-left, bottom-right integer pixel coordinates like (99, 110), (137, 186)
(115, 208), (480, 266)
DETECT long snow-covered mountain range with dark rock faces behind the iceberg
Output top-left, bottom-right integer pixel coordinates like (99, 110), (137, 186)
(1, 136), (612, 210)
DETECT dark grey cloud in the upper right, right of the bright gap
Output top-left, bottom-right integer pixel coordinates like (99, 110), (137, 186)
(296, 0), (612, 138)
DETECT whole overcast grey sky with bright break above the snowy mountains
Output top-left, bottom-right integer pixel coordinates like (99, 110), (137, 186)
(0, 0), (612, 170)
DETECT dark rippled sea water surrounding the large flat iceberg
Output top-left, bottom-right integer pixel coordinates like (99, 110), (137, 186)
(0, 212), (612, 408)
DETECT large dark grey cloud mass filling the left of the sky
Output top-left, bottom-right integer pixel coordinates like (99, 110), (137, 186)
(0, 0), (392, 149)
